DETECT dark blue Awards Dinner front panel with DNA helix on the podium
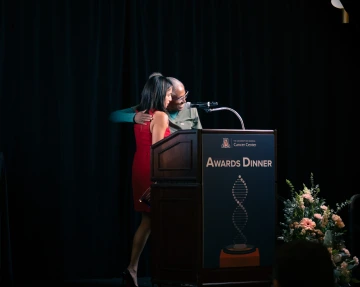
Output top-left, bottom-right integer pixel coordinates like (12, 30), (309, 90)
(202, 131), (276, 268)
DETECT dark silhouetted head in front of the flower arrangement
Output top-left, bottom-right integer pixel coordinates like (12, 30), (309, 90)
(274, 240), (335, 287)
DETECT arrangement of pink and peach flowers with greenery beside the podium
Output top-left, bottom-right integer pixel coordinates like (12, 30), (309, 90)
(280, 174), (360, 286)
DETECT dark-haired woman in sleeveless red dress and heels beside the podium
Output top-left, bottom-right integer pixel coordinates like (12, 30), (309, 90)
(123, 75), (172, 287)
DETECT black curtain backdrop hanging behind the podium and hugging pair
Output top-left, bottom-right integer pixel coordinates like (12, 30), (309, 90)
(0, 0), (360, 281)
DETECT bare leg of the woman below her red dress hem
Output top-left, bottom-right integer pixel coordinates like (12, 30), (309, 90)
(128, 212), (151, 286)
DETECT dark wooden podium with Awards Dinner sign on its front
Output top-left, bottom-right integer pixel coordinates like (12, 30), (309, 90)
(151, 129), (277, 286)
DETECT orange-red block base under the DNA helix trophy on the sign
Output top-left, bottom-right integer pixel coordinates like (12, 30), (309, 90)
(220, 248), (260, 268)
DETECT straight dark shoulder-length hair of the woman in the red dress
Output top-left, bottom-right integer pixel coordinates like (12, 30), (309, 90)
(138, 75), (172, 113)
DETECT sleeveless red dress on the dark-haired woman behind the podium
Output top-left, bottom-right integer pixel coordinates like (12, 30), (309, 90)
(132, 111), (170, 212)
